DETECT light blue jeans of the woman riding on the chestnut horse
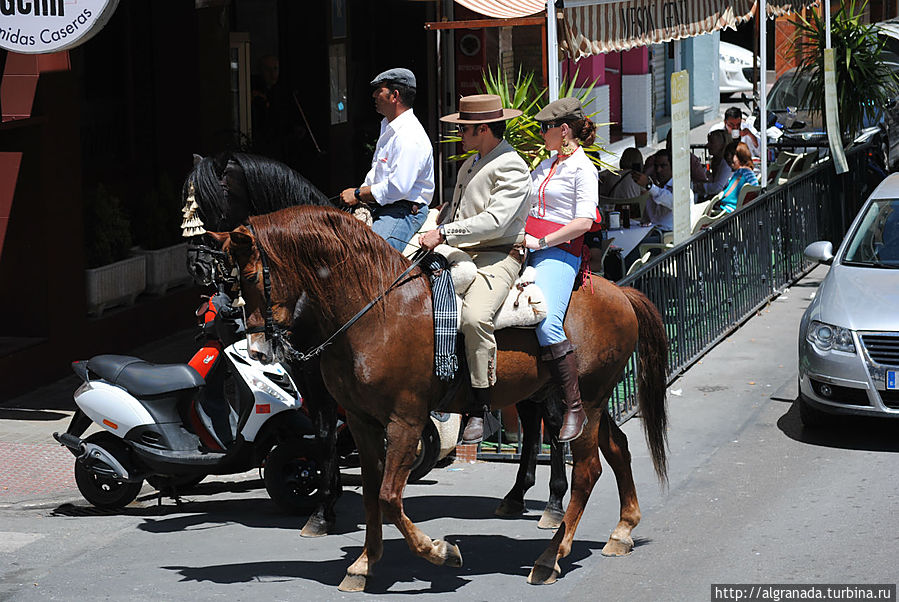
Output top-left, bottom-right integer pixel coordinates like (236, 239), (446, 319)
(528, 247), (581, 347)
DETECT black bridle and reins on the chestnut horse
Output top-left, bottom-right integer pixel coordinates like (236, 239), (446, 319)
(247, 224), (429, 363)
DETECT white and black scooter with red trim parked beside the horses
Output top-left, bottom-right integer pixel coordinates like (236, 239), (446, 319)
(53, 292), (321, 514)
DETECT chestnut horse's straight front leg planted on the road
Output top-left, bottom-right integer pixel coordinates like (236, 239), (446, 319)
(337, 412), (384, 592)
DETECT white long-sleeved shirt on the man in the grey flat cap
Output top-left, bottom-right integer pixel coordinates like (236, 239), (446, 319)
(362, 109), (434, 206)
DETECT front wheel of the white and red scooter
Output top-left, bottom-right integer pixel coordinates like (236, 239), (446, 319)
(263, 439), (322, 514)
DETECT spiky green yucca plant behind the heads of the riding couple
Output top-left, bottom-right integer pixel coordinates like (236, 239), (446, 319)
(442, 69), (612, 169)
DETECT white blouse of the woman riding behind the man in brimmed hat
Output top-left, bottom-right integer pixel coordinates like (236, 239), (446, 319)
(530, 147), (599, 224)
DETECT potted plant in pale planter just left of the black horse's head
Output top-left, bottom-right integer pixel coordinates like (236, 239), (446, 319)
(131, 176), (190, 295)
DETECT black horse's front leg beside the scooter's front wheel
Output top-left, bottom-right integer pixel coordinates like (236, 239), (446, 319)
(300, 396), (342, 537)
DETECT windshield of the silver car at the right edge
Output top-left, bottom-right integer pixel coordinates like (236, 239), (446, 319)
(842, 199), (899, 268)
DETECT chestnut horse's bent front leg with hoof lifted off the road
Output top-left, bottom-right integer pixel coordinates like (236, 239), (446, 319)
(380, 417), (462, 567)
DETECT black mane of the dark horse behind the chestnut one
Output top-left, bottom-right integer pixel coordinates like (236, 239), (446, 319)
(182, 152), (329, 231)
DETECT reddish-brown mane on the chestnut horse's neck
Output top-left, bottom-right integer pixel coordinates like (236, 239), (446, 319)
(249, 206), (426, 319)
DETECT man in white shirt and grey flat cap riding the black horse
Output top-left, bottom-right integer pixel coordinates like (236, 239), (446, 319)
(340, 68), (434, 252)
